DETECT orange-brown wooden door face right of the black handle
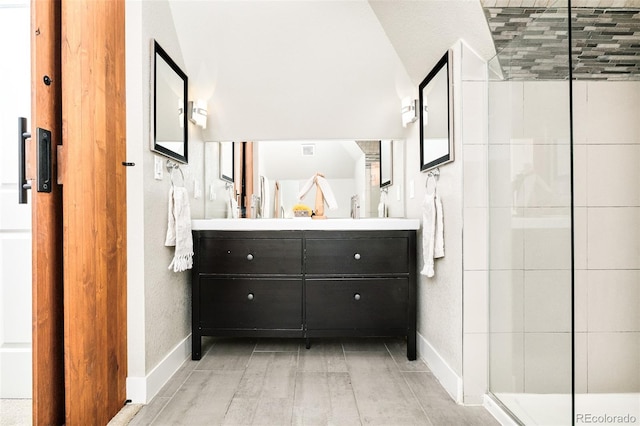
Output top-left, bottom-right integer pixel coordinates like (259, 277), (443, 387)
(61, 0), (127, 426)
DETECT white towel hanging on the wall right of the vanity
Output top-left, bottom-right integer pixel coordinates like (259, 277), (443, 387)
(420, 189), (444, 277)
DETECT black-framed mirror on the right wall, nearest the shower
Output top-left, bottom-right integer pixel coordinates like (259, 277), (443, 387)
(419, 52), (453, 171)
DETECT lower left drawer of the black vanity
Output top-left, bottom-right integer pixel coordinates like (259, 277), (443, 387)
(198, 277), (302, 330)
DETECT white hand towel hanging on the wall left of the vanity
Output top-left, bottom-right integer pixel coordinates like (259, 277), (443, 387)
(164, 185), (193, 272)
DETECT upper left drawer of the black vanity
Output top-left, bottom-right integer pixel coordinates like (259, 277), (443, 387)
(198, 236), (302, 274)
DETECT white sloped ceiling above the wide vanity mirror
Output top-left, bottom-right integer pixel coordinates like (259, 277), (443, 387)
(168, 0), (494, 140)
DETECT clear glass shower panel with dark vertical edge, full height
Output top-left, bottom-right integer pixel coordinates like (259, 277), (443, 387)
(485, 2), (573, 425)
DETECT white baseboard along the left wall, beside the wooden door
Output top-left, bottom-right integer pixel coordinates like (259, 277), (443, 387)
(127, 334), (191, 404)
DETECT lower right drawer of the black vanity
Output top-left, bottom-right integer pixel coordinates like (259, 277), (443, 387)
(306, 278), (409, 330)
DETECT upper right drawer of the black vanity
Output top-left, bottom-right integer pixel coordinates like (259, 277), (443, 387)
(305, 237), (409, 275)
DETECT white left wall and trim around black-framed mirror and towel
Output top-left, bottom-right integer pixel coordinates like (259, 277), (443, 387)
(126, 1), (203, 402)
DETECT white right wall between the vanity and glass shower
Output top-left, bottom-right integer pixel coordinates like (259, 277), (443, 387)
(405, 41), (488, 404)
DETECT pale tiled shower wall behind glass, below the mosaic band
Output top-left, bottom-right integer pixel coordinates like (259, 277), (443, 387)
(488, 81), (571, 394)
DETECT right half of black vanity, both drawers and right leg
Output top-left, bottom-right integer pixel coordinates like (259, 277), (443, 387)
(304, 231), (416, 360)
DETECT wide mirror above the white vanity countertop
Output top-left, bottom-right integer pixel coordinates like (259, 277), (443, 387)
(204, 140), (404, 218)
